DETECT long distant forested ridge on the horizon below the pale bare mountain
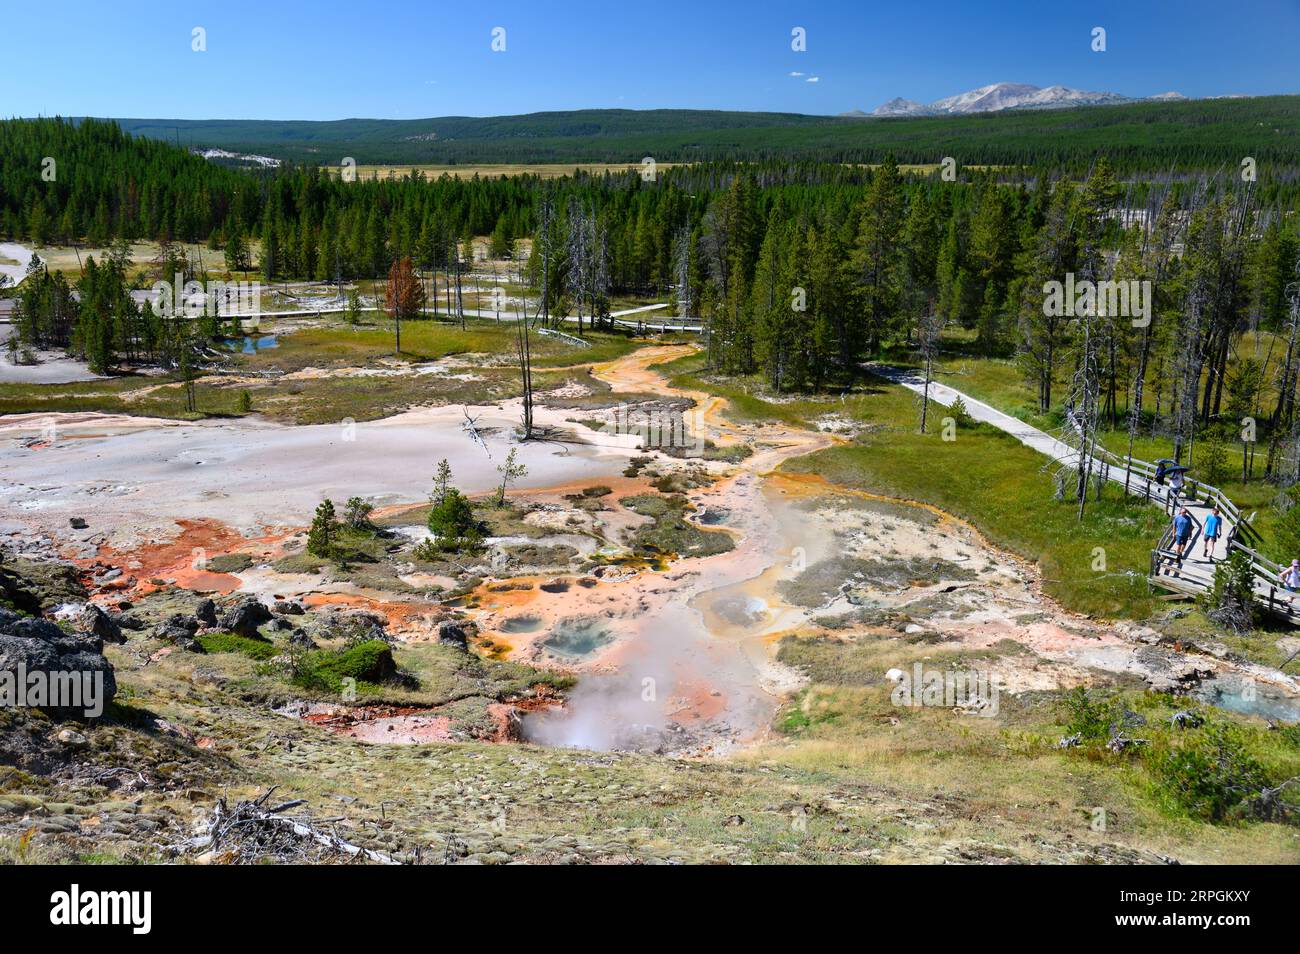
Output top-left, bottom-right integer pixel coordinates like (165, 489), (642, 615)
(106, 96), (1300, 173)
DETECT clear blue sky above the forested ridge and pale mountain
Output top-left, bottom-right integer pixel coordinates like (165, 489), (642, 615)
(0, 0), (1300, 120)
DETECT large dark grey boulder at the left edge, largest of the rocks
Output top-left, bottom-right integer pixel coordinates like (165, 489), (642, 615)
(0, 607), (117, 719)
